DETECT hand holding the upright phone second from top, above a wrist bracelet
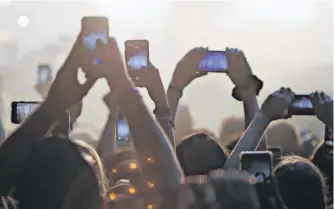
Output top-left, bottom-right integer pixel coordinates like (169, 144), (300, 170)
(135, 63), (168, 107)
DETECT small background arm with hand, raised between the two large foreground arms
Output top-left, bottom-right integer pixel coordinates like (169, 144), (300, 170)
(96, 92), (118, 158)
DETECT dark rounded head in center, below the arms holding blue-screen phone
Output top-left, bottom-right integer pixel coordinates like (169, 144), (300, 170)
(176, 132), (227, 176)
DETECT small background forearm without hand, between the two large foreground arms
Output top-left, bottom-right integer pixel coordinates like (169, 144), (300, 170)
(96, 111), (118, 158)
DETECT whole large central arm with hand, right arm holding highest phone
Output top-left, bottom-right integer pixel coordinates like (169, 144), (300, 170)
(99, 38), (183, 186)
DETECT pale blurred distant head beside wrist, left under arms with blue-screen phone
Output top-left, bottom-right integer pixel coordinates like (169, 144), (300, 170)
(174, 105), (194, 144)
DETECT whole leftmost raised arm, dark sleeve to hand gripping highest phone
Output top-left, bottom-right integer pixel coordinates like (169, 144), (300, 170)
(0, 36), (94, 196)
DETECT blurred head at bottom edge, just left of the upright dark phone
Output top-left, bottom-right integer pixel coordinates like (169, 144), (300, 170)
(210, 170), (260, 209)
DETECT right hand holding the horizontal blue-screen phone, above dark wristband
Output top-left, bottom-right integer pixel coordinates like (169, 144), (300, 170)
(226, 48), (252, 88)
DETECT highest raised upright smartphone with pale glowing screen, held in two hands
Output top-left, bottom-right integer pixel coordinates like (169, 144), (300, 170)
(81, 16), (109, 66)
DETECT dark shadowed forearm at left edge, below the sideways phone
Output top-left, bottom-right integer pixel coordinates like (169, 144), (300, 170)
(0, 104), (59, 196)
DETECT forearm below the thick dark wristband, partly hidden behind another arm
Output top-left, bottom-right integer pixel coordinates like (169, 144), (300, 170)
(241, 89), (267, 150)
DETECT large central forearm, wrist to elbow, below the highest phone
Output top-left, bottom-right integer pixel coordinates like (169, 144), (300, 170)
(120, 85), (183, 185)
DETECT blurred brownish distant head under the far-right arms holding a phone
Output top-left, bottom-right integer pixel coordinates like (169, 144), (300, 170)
(266, 122), (301, 155)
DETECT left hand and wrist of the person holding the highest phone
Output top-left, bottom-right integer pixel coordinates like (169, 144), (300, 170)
(45, 34), (96, 111)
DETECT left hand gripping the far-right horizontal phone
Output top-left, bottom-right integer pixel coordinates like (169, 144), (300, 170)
(261, 87), (295, 120)
